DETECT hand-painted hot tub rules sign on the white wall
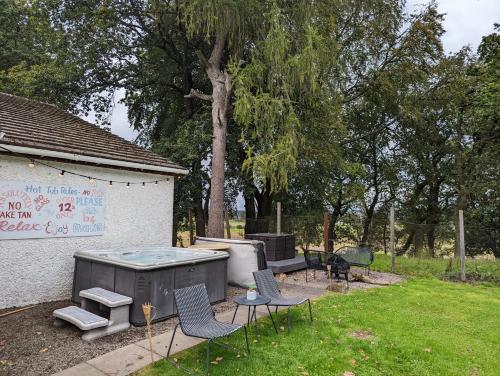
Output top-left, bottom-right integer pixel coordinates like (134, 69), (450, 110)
(0, 182), (105, 240)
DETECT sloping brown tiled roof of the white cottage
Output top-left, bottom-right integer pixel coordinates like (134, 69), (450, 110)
(0, 92), (187, 174)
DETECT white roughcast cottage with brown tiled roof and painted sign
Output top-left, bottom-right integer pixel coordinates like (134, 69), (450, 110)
(0, 93), (187, 308)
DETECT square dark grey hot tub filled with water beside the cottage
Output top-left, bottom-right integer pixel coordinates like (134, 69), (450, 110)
(73, 247), (229, 325)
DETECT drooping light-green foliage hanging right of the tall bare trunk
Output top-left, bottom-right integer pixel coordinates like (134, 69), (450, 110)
(234, 1), (342, 219)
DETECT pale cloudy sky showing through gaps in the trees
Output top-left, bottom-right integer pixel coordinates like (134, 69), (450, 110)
(94, 0), (500, 141)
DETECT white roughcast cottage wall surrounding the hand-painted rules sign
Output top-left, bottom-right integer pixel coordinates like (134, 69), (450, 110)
(0, 155), (174, 308)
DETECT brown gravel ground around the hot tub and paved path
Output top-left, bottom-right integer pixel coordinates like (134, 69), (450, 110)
(0, 271), (404, 376)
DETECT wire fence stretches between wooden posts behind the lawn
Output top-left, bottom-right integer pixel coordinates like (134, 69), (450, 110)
(259, 213), (500, 284)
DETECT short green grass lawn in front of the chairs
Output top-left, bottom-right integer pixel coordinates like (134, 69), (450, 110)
(138, 278), (500, 376)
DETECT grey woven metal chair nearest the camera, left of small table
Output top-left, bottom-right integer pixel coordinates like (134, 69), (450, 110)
(166, 284), (250, 375)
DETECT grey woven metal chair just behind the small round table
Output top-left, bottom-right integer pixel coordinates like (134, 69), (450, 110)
(253, 269), (312, 333)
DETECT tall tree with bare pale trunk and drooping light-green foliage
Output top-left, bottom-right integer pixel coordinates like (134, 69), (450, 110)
(181, 0), (336, 237)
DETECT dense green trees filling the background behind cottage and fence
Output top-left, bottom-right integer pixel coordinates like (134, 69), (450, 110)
(0, 0), (500, 255)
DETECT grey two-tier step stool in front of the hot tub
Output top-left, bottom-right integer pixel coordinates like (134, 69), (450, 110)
(53, 287), (132, 341)
